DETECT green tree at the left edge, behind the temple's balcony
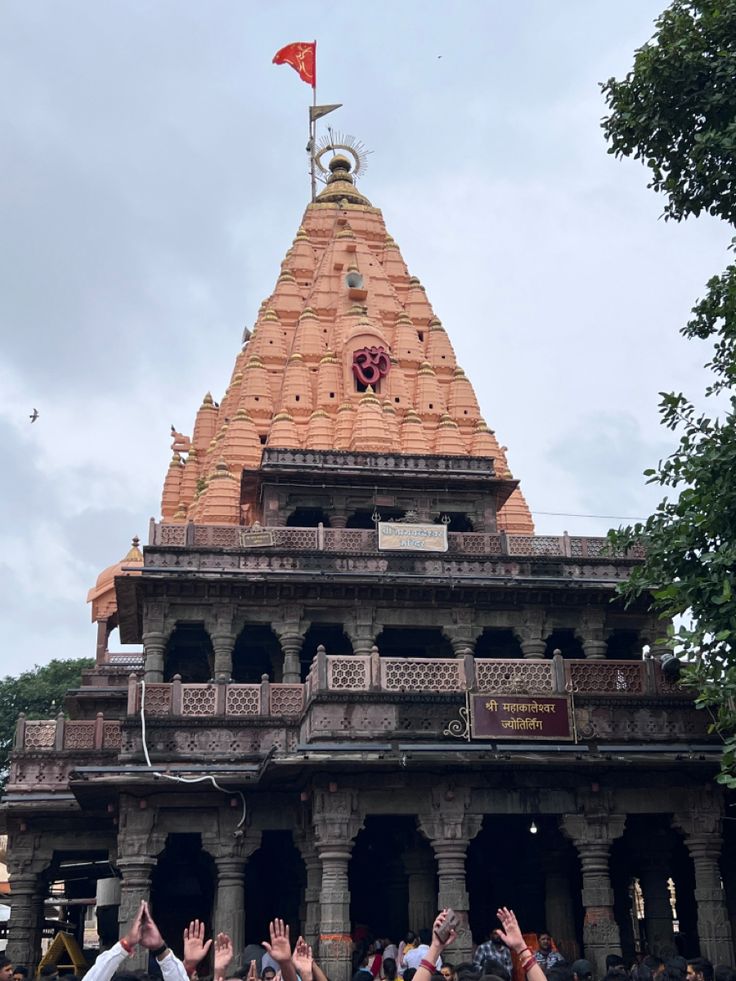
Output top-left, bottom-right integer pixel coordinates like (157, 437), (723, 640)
(0, 657), (94, 784)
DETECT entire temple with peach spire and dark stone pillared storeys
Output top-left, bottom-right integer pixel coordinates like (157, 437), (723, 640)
(2, 149), (736, 981)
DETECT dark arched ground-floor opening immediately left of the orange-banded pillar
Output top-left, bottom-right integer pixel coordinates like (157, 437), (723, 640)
(245, 831), (307, 944)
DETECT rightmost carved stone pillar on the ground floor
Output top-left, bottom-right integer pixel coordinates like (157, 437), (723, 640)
(673, 804), (734, 964)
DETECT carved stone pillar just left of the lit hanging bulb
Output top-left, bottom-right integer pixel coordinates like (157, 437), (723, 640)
(419, 785), (483, 963)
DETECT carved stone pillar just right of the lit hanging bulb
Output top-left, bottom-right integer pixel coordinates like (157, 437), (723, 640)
(560, 813), (626, 977)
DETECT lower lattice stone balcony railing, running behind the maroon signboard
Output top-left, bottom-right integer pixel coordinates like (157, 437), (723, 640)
(7, 648), (708, 794)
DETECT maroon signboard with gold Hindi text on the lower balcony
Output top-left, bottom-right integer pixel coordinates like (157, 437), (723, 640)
(470, 694), (573, 739)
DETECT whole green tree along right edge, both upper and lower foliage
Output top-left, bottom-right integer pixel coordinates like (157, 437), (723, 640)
(602, 0), (736, 787)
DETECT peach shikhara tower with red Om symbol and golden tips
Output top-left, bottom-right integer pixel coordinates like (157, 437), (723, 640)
(161, 156), (534, 535)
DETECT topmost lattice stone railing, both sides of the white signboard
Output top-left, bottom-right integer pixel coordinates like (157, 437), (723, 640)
(148, 521), (644, 561)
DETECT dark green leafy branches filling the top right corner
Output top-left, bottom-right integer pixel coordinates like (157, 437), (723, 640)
(602, 0), (736, 223)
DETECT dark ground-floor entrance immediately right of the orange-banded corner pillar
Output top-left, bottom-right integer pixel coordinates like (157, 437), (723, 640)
(348, 814), (437, 943)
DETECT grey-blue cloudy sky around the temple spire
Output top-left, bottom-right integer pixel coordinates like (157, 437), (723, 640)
(0, 0), (729, 674)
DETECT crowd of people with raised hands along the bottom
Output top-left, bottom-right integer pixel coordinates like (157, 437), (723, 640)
(0, 901), (736, 981)
